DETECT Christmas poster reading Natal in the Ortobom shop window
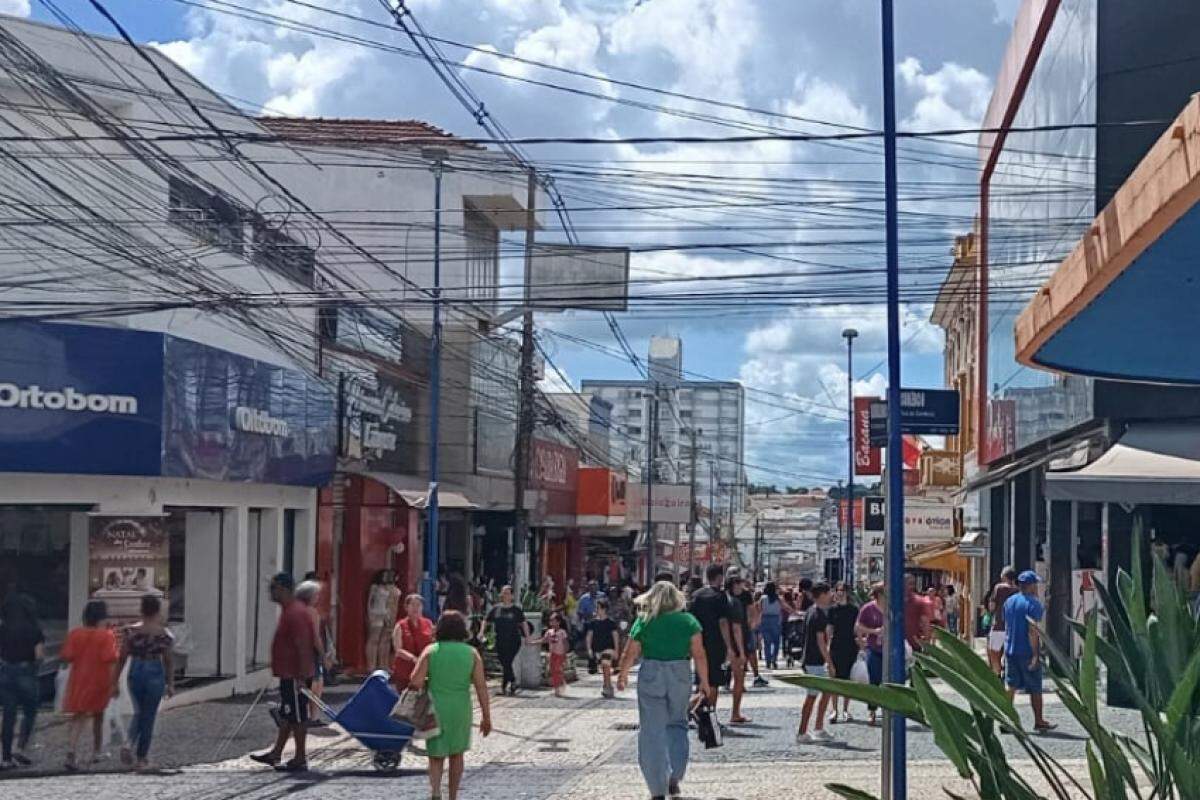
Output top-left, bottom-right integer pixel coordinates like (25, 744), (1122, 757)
(88, 517), (170, 624)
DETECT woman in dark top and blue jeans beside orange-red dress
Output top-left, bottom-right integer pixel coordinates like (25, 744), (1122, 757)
(113, 595), (175, 770)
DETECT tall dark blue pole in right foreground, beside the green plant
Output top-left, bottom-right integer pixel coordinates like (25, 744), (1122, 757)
(881, 0), (908, 800)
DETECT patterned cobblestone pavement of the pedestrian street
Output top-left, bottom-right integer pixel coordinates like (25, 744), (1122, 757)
(0, 678), (1138, 800)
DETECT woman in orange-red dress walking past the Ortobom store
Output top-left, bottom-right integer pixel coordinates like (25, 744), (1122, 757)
(59, 600), (121, 772)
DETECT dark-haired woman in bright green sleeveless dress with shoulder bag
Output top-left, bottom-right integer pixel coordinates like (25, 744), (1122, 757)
(409, 610), (492, 800)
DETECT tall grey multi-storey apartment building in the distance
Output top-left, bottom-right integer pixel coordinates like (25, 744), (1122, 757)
(581, 336), (746, 513)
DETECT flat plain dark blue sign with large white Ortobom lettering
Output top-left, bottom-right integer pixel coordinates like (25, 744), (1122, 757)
(0, 321), (163, 475)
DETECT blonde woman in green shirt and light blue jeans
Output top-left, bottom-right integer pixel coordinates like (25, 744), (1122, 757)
(617, 581), (709, 799)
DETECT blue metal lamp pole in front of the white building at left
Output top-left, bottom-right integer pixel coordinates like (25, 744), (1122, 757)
(421, 148), (446, 619)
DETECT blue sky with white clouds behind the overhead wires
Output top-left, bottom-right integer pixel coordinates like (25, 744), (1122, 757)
(16, 0), (1018, 486)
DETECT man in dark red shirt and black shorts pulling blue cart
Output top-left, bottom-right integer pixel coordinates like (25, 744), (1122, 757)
(251, 572), (317, 772)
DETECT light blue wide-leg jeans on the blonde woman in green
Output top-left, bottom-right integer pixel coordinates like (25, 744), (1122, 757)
(637, 660), (691, 798)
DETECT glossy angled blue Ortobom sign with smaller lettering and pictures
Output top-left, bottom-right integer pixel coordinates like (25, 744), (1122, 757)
(163, 337), (337, 486)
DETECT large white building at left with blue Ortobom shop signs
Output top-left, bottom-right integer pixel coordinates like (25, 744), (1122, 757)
(0, 17), (535, 691)
